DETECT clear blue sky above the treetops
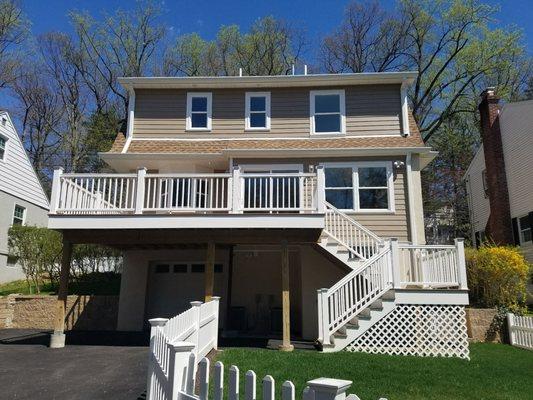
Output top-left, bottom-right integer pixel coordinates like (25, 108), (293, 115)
(22, 0), (533, 52)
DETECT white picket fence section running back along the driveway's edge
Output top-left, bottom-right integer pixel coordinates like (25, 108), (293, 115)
(146, 297), (220, 400)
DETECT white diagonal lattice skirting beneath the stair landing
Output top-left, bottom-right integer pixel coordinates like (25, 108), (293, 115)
(346, 304), (470, 360)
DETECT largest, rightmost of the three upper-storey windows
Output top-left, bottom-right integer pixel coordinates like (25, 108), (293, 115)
(310, 90), (346, 135)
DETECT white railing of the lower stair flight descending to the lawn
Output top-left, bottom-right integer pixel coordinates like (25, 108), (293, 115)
(318, 245), (393, 345)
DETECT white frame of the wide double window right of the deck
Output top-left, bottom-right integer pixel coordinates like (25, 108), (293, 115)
(320, 161), (396, 214)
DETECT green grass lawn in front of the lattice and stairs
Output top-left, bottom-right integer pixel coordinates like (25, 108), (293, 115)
(217, 343), (533, 400)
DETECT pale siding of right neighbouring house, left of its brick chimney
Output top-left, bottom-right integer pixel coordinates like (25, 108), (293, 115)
(465, 146), (490, 240)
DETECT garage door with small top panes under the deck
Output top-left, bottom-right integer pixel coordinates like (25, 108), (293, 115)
(146, 262), (226, 319)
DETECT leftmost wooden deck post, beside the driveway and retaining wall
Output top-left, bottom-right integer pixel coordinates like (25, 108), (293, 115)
(50, 237), (72, 349)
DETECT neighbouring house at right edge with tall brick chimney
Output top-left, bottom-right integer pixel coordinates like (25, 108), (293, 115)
(464, 88), (533, 262)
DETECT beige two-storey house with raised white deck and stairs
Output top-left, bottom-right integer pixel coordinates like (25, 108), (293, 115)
(49, 72), (468, 351)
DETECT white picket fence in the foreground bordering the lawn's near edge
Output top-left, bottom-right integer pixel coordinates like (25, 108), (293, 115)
(157, 342), (386, 400)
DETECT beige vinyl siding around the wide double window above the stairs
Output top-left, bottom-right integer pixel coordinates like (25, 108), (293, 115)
(233, 157), (411, 241)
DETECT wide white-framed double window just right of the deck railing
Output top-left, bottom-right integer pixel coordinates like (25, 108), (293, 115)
(324, 162), (394, 212)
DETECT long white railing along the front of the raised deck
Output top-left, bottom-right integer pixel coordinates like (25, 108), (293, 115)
(50, 168), (324, 215)
